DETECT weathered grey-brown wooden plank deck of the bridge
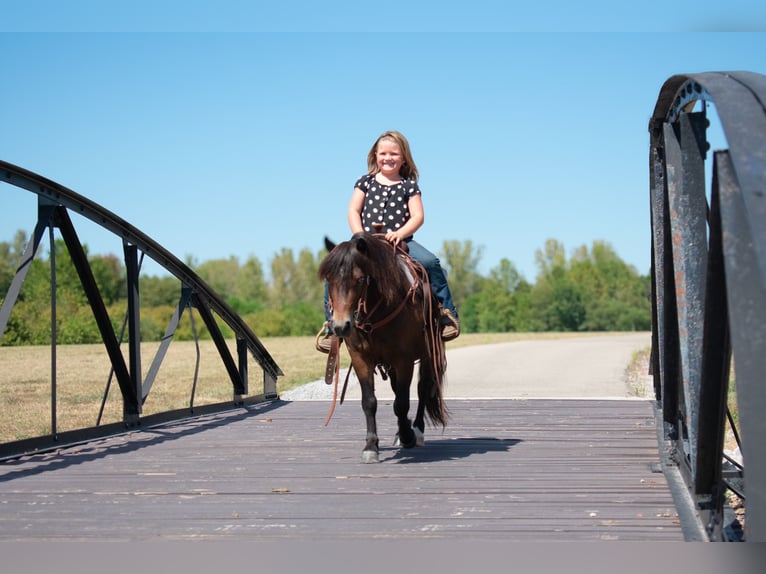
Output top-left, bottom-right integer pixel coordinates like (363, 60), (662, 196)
(0, 399), (683, 541)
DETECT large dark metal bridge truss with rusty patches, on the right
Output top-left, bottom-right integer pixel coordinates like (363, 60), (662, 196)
(649, 72), (766, 541)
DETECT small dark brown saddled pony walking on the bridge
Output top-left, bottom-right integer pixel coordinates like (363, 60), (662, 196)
(319, 233), (447, 462)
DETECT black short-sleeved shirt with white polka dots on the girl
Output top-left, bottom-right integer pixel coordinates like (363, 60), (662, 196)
(354, 174), (420, 238)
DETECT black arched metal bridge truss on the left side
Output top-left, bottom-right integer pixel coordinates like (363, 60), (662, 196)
(0, 161), (283, 456)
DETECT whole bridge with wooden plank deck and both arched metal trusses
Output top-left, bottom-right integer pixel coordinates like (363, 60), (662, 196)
(0, 72), (766, 541)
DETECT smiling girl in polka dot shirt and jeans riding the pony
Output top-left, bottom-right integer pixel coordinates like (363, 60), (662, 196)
(317, 131), (460, 353)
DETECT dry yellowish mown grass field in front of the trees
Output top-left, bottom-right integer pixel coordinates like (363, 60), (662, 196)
(0, 333), (632, 442)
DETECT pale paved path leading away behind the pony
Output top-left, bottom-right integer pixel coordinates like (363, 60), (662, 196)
(281, 333), (651, 400)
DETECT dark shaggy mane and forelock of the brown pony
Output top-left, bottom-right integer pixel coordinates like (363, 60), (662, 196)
(319, 233), (410, 303)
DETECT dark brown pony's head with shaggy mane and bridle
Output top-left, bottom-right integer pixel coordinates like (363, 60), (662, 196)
(319, 233), (409, 337)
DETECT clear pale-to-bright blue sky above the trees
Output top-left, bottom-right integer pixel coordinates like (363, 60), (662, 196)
(0, 0), (766, 280)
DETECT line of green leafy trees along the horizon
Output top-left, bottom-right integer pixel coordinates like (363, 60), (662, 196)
(0, 231), (651, 345)
